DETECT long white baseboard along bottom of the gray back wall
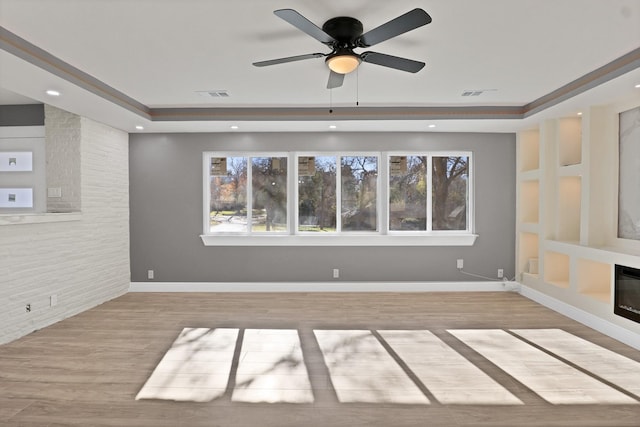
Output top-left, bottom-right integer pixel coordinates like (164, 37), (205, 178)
(129, 281), (517, 292)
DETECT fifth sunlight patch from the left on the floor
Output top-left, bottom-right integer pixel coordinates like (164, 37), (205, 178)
(448, 329), (638, 404)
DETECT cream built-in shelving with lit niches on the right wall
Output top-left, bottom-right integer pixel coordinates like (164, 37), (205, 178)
(516, 101), (640, 340)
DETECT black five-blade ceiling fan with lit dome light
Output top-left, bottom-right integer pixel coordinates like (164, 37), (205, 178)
(253, 8), (431, 89)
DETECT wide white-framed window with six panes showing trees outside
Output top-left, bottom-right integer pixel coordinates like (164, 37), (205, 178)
(203, 152), (475, 245)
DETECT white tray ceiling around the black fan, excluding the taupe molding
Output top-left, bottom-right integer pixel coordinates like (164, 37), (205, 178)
(0, 0), (640, 132)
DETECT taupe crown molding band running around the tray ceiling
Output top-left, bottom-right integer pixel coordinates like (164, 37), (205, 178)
(0, 26), (640, 122)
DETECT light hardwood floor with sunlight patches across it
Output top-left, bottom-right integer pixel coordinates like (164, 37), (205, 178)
(0, 293), (640, 427)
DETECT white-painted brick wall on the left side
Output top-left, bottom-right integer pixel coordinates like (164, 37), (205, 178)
(0, 108), (130, 344)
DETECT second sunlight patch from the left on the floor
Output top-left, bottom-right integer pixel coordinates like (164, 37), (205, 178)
(231, 329), (313, 403)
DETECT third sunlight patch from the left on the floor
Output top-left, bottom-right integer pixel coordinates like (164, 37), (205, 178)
(313, 330), (429, 404)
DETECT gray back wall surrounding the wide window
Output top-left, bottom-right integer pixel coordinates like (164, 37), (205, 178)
(129, 133), (516, 282)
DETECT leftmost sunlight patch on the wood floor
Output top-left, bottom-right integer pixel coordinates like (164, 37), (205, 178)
(136, 328), (238, 402)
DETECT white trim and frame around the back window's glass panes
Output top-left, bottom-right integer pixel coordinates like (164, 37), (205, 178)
(200, 150), (478, 246)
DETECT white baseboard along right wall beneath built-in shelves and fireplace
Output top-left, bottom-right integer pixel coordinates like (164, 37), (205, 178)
(520, 285), (640, 350)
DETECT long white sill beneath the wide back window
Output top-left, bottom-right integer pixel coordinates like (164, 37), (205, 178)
(200, 233), (478, 246)
